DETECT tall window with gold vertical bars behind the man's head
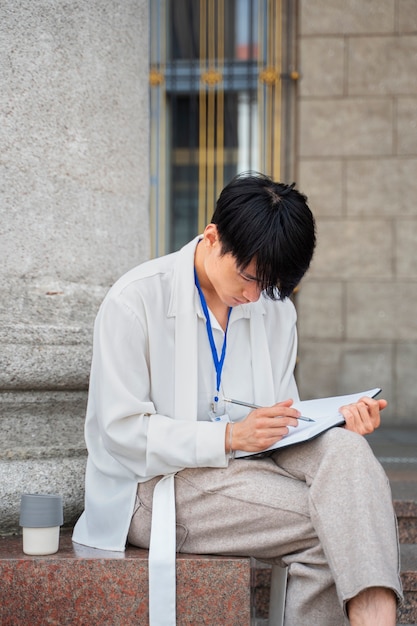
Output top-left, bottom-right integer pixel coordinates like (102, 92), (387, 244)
(150, 0), (291, 256)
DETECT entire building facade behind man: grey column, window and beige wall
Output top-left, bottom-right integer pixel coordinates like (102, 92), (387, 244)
(0, 0), (417, 532)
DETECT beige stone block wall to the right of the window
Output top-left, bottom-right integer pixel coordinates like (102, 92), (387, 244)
(297, 0), (417, 424)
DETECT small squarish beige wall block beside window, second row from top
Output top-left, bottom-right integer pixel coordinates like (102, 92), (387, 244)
(300, 37), (345, 98)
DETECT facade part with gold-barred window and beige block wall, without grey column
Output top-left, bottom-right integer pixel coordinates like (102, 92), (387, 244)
(150, 0), (417, 423)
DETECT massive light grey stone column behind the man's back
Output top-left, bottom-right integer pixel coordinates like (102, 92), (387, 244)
(0, 0), (149, 533)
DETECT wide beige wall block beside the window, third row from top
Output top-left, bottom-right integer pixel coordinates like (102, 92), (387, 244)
(299, 98), (393, 157)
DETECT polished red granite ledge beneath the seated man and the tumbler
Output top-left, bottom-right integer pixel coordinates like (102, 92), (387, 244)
(0, 532), (251, 626)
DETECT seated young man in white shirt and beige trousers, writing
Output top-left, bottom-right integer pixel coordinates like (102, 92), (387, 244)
(73, 175), (401, 626)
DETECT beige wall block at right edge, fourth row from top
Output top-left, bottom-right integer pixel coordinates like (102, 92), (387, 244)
(346, 157), (417, 218)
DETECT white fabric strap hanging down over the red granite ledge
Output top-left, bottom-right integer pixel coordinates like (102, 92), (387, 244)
(149, 474), (176, 626)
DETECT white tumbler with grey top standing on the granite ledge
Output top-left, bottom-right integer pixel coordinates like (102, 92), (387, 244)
(20, 493), (64, 555)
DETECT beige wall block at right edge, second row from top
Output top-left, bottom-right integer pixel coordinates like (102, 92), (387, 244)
(347, 35), (417, 96)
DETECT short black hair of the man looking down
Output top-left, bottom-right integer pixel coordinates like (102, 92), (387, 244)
(211, 173), (316, 300)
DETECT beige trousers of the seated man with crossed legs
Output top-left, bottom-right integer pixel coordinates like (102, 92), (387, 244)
(128, 428), (402, 626)
